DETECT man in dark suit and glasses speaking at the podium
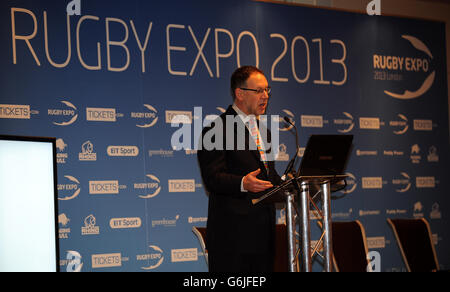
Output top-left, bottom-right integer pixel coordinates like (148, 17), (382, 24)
(198, 66), (280, 272)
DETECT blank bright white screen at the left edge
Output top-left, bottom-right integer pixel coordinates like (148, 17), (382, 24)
(0, 140), (57, 272)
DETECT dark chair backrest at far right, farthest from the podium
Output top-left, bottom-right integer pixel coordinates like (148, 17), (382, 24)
(387, 218), (439, 272)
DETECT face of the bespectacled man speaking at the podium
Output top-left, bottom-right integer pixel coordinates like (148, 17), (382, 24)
(237, 73), (269, 116)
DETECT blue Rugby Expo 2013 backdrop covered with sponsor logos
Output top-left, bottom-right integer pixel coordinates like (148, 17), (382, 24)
(0, 0), (450, 271)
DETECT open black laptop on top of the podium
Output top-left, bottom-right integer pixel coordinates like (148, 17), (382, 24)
(297, 135), (353, 176)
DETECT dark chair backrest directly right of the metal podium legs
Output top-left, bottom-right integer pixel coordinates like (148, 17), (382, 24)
(331, 220), (369, 272)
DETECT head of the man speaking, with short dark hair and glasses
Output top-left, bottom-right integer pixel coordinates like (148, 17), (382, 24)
(231, 66), (270, 116)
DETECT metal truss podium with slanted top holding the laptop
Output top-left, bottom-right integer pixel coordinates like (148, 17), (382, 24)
(252, 175), (347, 272)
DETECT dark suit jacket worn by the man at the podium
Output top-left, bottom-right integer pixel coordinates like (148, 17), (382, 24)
(198, 106), (280, 253)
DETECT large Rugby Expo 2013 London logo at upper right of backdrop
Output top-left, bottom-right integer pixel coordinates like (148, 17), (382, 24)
(373, 35), (436, 100)
